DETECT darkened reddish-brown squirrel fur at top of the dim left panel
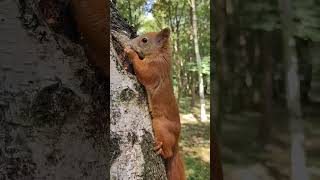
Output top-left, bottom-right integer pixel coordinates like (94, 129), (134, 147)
(70, 0), (110, 77)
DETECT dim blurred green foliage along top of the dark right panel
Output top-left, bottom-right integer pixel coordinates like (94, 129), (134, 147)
(239, 0), (320, 41)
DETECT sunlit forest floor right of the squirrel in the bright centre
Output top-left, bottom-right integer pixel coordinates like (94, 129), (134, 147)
(180, 97), (210, 180)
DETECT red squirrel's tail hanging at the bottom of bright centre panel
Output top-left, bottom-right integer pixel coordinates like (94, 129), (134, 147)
(166, 151), (186, 180)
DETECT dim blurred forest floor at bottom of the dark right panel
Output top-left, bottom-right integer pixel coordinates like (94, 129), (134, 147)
(220, 104), (320, 180)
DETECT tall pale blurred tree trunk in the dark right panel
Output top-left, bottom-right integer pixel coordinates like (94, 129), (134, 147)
(279, 0), (309, 180)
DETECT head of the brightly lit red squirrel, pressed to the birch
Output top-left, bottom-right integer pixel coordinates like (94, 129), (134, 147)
(128, 28), (170, 59)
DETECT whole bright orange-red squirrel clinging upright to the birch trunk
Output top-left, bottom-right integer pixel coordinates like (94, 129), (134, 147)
(124, 28), (186, 180)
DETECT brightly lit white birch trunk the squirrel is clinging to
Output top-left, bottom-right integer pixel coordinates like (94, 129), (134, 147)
(110, 1), (166, 180)
